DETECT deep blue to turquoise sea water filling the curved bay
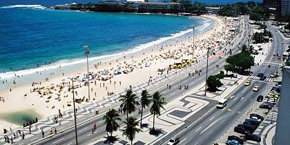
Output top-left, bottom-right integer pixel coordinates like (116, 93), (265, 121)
(0, 7), (204, 72)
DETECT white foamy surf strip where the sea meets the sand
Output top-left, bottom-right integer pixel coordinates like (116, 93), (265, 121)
(0, 16), (213, 91)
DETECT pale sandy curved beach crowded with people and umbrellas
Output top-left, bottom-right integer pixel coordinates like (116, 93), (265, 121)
(0, 15), (238, 134)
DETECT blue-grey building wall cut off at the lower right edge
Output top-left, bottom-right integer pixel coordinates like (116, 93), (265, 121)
(274, 66), (290, 145)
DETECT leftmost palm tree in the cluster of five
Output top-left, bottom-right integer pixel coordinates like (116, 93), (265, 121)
(104, 109), (121, 137)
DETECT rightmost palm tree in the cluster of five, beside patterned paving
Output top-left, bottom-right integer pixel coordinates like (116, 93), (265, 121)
(150, 91), (166, 130)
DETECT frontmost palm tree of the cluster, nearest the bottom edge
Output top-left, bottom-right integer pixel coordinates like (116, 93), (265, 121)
(122, 117), (140, 145)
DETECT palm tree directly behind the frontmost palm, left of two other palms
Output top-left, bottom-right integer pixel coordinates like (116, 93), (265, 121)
(120, 89), (139, 120)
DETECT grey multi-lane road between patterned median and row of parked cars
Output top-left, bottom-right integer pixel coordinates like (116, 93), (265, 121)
(171, 20), (285, 145)
